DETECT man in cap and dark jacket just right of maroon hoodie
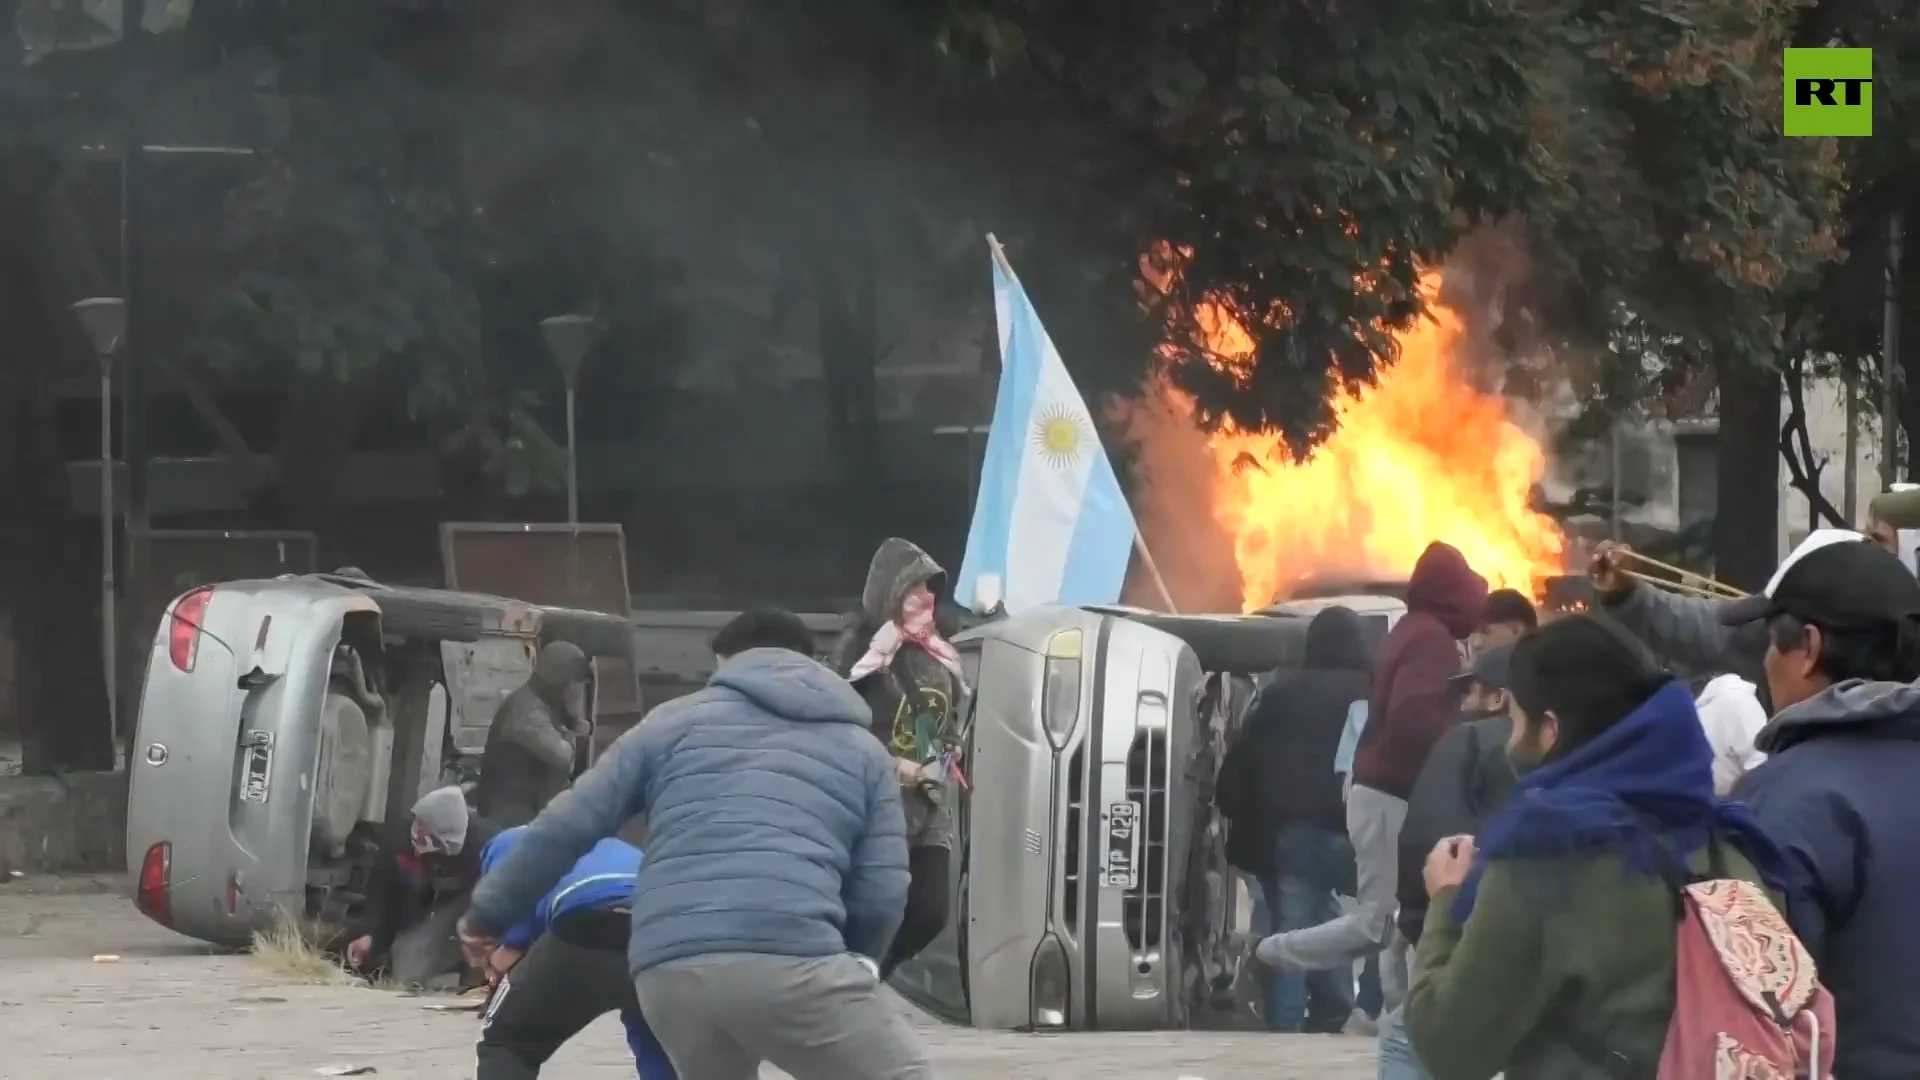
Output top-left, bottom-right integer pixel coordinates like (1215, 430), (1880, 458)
(1380, 642), (1515, 1080)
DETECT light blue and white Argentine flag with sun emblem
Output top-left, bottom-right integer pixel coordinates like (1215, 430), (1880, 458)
(954, 238), (1135, 613)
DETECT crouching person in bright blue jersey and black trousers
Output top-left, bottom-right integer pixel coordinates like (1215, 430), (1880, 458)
(478, 826), (678, 1080)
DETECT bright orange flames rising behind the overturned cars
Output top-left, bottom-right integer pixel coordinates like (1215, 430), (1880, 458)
(1136, 275), (1565, 611)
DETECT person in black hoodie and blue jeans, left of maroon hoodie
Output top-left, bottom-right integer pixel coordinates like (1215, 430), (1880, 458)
(1215, 607), (1373, 1034)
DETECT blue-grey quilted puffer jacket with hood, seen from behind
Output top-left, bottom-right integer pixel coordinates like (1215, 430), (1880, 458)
(467, 650), (908, 972)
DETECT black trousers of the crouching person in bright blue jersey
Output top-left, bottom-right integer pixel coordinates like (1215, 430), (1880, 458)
(478, 911), (664, 1080)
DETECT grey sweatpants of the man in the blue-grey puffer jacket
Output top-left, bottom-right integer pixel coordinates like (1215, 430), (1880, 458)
(634, 953), (933, 1080)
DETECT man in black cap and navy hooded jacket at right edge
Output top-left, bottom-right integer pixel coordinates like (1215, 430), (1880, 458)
(1720, 528), (1920, 1080)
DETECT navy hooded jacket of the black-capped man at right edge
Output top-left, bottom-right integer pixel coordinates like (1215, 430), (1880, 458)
(1734, 682), (1920, 1080)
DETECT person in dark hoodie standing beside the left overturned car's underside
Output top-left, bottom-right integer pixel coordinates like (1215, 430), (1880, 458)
(474, 642), (593, 828)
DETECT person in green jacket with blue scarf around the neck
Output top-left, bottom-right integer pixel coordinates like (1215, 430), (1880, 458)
(1407, 615), (1788, 1080)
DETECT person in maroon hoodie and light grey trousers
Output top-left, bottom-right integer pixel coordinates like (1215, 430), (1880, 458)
(1252, 542), (1486, 1009)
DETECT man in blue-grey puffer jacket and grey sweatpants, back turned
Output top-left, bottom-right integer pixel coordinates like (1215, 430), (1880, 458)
(461, 611), (933, 1080)
